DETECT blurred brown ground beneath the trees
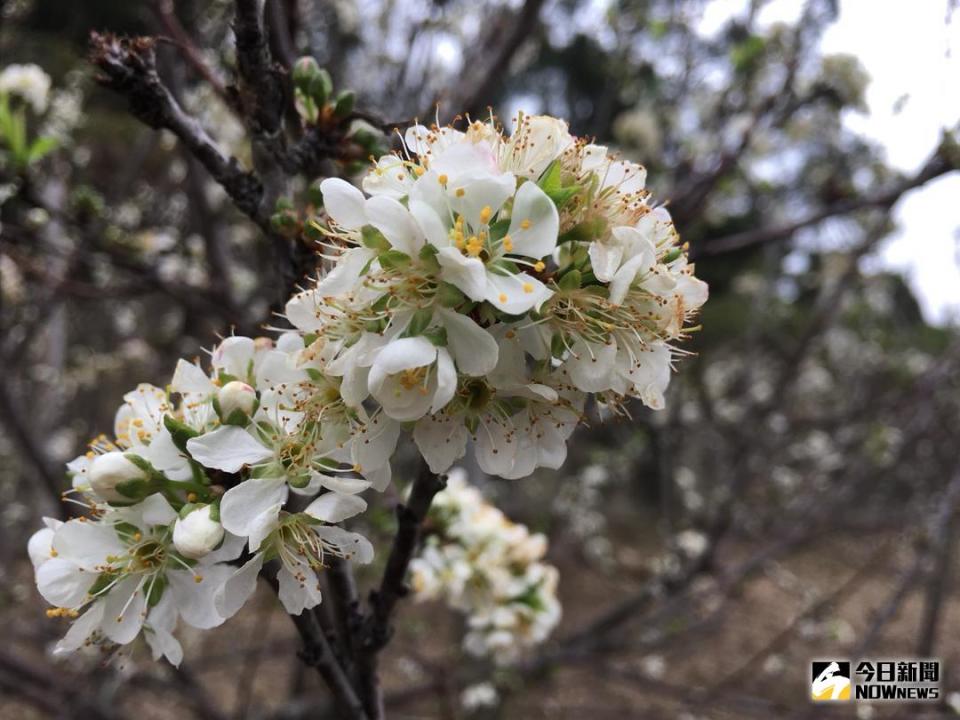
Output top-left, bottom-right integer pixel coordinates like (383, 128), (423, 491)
(0, 519), (960, 720)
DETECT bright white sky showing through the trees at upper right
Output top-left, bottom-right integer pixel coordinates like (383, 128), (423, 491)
(700, 0), (960, 323)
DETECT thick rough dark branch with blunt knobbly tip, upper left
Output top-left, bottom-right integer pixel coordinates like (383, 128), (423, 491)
(90, 32), (269, 231)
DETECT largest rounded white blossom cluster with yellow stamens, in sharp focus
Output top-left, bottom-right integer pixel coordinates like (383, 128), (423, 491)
(286, 115), (707, 478)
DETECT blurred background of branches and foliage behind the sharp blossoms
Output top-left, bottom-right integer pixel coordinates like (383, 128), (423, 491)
(0, 0), (960, 717)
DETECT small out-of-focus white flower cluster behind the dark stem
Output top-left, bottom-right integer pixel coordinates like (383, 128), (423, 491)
(410, 468), (560, 665)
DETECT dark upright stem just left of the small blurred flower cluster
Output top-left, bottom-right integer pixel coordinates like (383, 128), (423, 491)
(356, 463), (447, 720)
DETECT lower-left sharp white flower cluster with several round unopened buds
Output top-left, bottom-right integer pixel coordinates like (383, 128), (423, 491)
(28, 334), (376, 664)
